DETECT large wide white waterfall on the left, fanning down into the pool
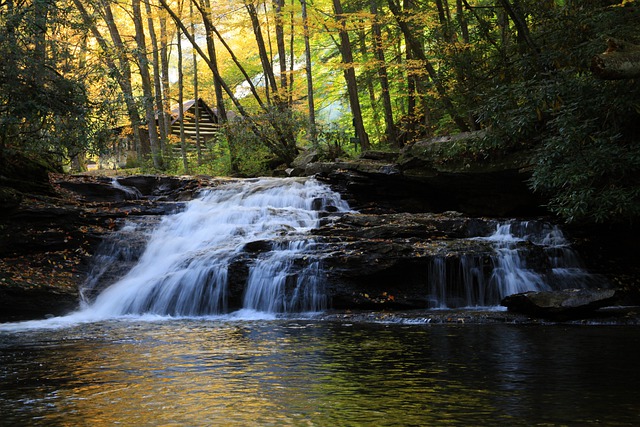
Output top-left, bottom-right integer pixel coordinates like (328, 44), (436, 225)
(86, 178), (349, 317)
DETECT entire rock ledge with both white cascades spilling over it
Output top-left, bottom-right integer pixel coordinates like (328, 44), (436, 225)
(82, 178), (603, 318)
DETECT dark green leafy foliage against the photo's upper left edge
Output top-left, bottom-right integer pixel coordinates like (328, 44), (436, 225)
(0, 1), (91, 164)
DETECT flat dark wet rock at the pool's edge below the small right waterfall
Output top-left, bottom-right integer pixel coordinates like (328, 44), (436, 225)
(501, 289), (618, 321)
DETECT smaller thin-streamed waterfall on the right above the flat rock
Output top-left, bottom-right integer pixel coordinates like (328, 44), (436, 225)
(428, 221), (603, 308)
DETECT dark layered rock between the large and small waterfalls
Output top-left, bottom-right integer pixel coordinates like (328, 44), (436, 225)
(314, 212), (495, 310)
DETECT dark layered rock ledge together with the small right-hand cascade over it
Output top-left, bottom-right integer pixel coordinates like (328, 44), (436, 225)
(317, 216), (607, 309)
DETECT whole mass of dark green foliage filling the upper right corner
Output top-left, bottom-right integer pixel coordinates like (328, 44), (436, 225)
(465, 2), (640, 222)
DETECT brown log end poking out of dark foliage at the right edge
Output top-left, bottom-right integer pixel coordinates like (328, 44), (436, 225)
(591, 39), (640, 80)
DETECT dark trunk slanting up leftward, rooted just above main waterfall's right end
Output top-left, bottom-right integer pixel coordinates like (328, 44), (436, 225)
(333, 0), (371, 151)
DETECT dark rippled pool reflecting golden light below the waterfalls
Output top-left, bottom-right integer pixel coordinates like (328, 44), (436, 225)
(0, 319), (640, 426)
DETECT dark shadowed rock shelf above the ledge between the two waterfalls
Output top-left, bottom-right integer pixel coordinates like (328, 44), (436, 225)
(293, 133), (546, 216)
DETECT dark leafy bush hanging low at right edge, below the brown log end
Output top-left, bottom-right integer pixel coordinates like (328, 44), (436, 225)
(531, 76), (640, 222)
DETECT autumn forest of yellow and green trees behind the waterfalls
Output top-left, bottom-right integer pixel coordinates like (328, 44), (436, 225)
(0, 0), (640, 223)
